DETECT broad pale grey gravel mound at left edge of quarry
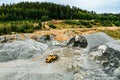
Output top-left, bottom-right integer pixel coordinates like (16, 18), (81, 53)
(0, 39), (48, 62)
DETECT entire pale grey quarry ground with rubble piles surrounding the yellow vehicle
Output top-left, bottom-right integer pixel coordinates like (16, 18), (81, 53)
(0, 33), (120, 80)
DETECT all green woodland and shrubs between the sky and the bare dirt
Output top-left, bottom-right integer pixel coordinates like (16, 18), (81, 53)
(0, 2), (120, 35)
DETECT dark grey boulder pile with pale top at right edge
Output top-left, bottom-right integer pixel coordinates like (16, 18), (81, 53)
(98, 41), (120, 75)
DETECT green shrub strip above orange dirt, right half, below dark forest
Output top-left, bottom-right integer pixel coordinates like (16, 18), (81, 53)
(64, 20), (120, 28)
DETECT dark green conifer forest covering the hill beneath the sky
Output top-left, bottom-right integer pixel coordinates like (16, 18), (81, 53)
(0, 2), (120, 21)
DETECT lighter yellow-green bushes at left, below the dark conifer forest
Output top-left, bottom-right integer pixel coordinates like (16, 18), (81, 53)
(0, 21), (42, 35)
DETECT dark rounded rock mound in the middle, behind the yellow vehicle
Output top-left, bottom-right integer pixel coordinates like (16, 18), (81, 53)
(67, 35), (88, 48)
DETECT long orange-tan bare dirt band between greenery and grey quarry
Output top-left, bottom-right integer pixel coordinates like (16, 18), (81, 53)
(1, 27), (120, 41)
